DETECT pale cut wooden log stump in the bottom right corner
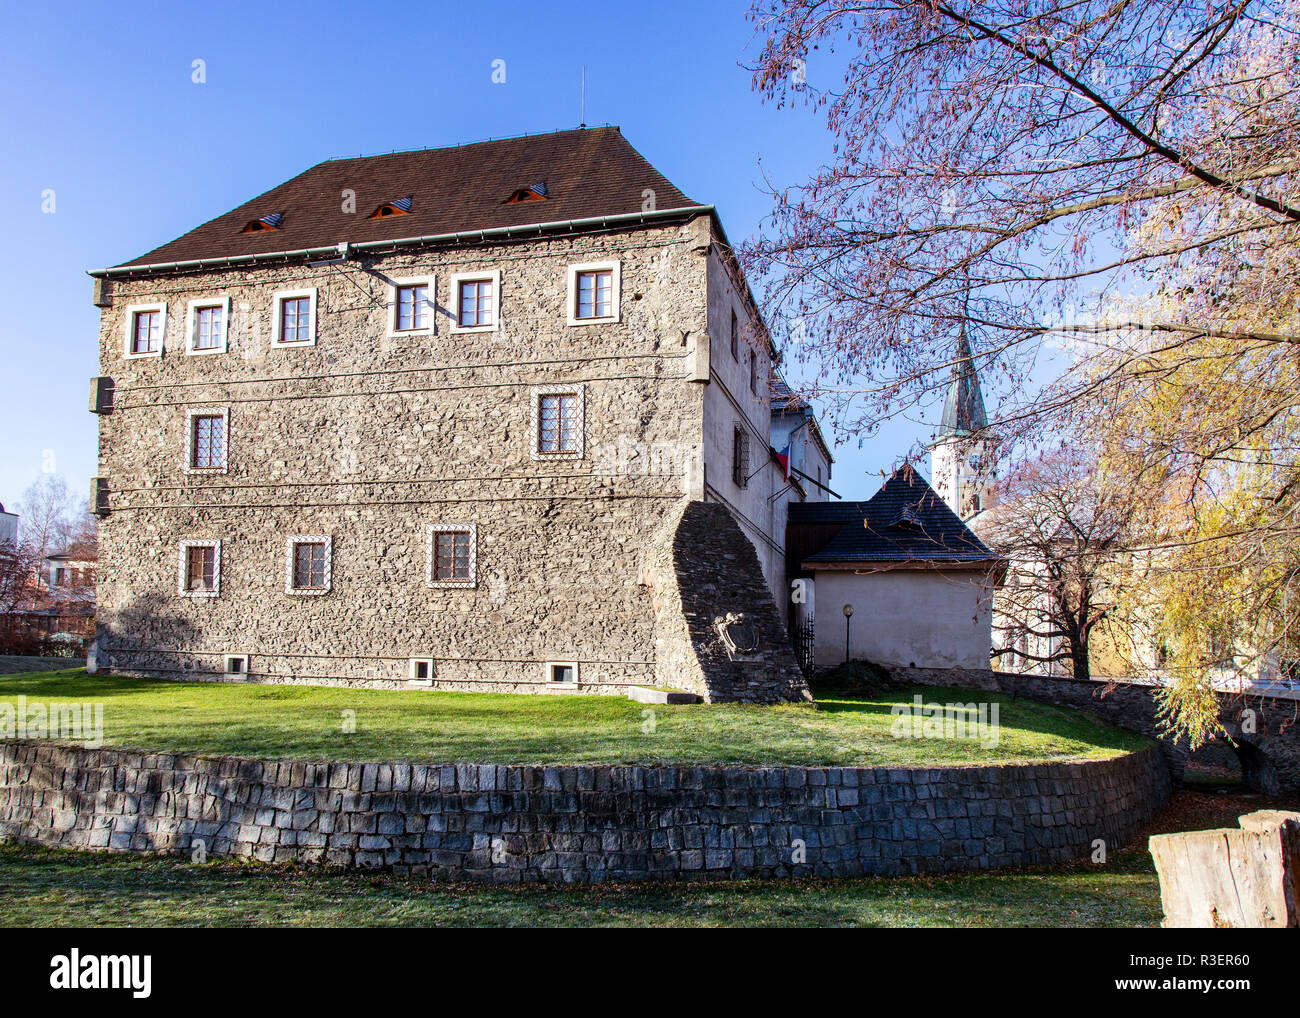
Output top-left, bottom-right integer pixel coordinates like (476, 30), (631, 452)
(1148, 810), (1300, 928)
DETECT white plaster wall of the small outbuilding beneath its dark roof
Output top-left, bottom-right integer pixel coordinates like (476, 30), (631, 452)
(815, 569), (992, 668)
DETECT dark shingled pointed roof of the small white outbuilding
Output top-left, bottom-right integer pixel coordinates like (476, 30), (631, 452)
(789, 464), (1001, 566)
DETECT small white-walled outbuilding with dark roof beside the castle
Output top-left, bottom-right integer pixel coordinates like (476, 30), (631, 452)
(787, 464), (1006, 670)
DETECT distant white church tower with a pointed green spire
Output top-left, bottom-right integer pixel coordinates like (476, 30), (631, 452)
(930, 319), (997, 520)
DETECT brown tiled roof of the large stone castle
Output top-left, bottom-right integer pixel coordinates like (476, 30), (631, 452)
(114, 127), (697, 265)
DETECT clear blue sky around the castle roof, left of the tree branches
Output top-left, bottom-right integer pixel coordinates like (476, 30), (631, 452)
(0, 0), (939, 503)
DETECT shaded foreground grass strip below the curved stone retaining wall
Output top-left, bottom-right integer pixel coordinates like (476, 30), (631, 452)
(0, 845), (1161, 927)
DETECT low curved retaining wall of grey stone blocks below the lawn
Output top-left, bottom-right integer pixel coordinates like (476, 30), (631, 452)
(0, 742), (1170, 883)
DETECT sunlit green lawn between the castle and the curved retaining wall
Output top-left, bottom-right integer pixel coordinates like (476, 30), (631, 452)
(0, 670), (1149, 766)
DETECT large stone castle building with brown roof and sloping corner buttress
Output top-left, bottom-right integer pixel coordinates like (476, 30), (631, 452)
(91, 127), (831, 701)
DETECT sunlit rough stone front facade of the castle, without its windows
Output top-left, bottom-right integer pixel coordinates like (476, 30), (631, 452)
(98, 217), (795, 693)
